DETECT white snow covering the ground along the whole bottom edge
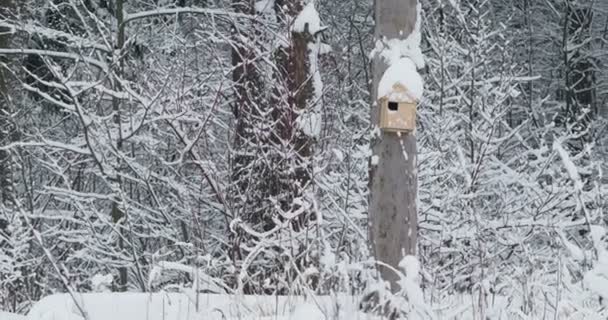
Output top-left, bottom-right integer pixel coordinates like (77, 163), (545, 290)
(13, 293), (605, 320)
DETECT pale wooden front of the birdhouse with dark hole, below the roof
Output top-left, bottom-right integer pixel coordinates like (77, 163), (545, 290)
(379, 99), (416, 132)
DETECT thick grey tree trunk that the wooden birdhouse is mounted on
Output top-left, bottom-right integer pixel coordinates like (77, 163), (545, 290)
(369, 0), (418, 290)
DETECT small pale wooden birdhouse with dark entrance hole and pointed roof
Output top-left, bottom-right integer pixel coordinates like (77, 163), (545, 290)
(379, 83), (417, 132)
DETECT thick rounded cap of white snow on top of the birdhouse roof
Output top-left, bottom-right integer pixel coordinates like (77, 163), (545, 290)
(378, 58), (424, 102)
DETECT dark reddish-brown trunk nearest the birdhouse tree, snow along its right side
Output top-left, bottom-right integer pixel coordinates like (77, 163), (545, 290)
(274, 0), (318, 230)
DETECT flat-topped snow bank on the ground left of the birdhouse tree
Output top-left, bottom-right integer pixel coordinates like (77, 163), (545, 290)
(28, 293), (382, 320)
